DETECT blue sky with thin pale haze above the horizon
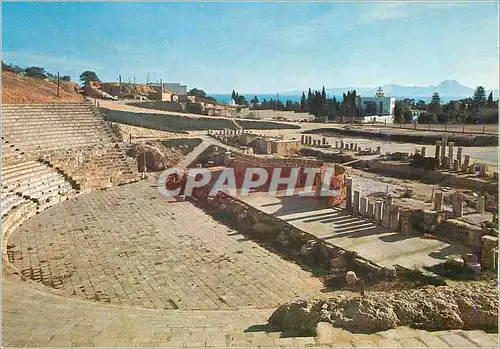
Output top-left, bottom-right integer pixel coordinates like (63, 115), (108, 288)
(2, 2), (499, 93)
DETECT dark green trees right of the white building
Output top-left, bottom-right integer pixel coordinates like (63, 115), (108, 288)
(394, 86), (498, 124)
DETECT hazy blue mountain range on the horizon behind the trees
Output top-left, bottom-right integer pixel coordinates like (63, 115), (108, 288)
(287, 80), (498, 100)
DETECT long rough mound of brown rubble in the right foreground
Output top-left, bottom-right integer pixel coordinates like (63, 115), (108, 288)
(268, 282), (498, 336)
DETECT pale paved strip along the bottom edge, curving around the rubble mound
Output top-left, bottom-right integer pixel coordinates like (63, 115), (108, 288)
(2, 277), (498, 348)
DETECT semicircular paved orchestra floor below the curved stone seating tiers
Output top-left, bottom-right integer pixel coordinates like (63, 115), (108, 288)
(8, 181), (323, 309)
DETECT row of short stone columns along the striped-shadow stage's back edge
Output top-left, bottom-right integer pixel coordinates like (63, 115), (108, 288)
(346, 178), (402, 231)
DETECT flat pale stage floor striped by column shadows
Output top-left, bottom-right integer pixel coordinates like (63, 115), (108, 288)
(240, 193), (468, 269)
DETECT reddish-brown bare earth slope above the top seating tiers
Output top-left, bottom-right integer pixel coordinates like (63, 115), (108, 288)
(2, 72), (82, 104)
